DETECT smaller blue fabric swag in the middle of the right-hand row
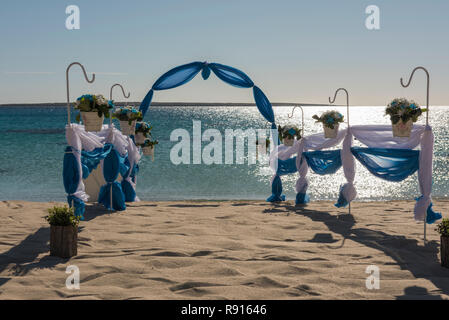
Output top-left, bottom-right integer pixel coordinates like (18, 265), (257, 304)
(303, 150), (341, 175)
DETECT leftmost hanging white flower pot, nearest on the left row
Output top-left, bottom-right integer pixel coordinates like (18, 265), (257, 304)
(75, 94), (114, 131)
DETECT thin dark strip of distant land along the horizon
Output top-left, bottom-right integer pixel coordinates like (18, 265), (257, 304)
(0, 101), (341, 108)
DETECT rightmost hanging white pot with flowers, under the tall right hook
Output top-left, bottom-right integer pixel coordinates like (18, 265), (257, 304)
(385, 98), (427, 137)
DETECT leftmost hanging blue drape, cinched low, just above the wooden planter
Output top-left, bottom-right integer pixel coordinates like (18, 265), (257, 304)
(62, 147), (85, 220)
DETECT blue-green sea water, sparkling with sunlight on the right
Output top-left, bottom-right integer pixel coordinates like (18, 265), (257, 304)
(0, 106), (449, 201)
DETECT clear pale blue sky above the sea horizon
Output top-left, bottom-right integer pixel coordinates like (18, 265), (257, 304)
(0, 0), (449, 105)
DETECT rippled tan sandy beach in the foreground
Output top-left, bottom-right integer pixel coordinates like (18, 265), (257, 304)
(0, 200), (449, 299)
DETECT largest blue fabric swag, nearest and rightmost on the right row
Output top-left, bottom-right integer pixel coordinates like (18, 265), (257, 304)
(351, 147), (419, 182)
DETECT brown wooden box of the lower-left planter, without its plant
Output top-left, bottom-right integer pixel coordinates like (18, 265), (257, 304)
(50, 226), (78, 258)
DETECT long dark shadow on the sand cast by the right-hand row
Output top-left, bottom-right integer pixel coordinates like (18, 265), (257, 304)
(264, 204), (449, 299)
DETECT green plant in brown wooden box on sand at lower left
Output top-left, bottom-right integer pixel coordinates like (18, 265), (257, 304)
(45, 206), (80, 258)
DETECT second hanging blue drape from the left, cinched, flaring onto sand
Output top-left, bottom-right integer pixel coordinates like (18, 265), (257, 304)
(98, 150), (126, 211)
